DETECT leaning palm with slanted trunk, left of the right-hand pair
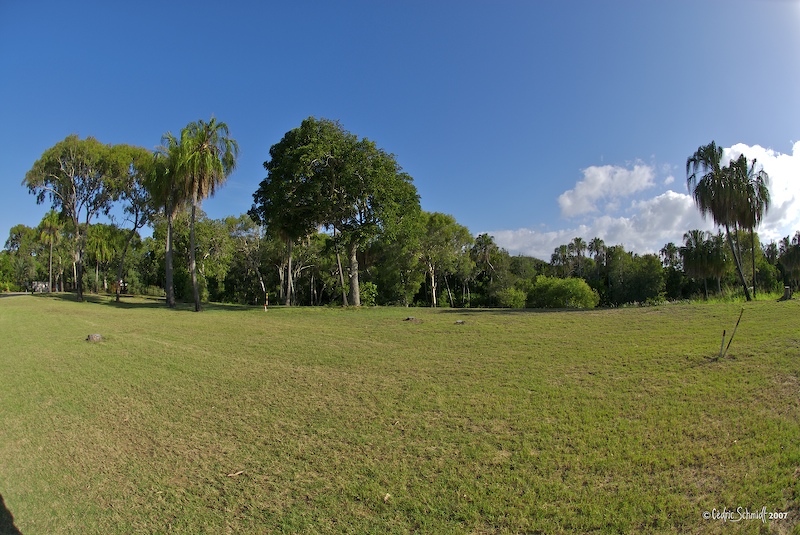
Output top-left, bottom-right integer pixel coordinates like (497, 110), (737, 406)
(686, 141), (751, 301)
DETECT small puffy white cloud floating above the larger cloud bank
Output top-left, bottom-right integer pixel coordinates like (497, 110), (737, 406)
(558, 164), (654, 217)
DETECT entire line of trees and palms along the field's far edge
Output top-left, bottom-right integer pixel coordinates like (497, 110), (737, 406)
(0, 125), (800, 310)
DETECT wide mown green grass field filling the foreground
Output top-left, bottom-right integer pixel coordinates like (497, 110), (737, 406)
(0, 296), (800, 535)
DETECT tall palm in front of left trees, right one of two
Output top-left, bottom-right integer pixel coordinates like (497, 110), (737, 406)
(177, 117), (239, 312)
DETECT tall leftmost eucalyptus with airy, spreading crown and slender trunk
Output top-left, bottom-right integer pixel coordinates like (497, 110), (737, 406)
(22, 135), (128, 301)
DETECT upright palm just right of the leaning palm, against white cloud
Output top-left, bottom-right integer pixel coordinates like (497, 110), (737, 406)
(729, 154), (770, 298)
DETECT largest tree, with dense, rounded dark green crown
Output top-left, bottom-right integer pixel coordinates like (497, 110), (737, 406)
(249, 117), (420, 306)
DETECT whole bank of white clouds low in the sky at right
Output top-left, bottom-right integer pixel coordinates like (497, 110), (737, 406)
(489, 142), (800, 261)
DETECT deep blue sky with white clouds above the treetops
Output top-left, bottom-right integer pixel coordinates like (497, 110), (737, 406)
(0, 0), (800, 260)
